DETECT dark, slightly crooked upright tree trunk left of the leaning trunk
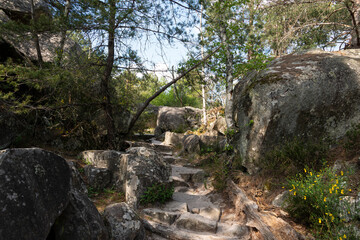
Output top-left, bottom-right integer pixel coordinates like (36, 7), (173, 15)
(101, 0), (116, 148)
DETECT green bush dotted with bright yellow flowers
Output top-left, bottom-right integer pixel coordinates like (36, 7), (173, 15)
(287, 167), (355, 240)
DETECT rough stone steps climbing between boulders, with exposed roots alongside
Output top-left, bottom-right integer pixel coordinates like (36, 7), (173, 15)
(136, 141), (303, 240)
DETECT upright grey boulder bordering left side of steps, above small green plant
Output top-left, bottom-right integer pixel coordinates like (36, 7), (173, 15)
(123, 147), (171, 208)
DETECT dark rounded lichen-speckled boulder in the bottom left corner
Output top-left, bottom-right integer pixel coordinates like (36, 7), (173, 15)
(0, 148), (70, 240)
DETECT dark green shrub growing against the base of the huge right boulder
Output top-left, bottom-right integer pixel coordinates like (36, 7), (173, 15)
(260, 138), (328, 175)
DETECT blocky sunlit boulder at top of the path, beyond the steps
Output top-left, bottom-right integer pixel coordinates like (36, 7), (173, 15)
(155, 107), (201, 136)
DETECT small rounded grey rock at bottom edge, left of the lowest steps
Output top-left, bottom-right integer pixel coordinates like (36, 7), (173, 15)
(104, 203), (145, 240)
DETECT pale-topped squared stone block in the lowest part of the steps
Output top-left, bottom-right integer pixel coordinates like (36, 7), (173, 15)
(175, 213), (217, 233)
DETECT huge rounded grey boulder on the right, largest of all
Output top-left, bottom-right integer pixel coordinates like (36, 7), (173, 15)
(233, 49), (360, 172)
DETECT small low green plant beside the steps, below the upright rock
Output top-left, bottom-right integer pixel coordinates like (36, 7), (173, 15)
(140, 183), (174, 205)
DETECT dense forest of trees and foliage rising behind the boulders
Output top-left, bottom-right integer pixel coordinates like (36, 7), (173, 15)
(0, 0), (360, 149)
